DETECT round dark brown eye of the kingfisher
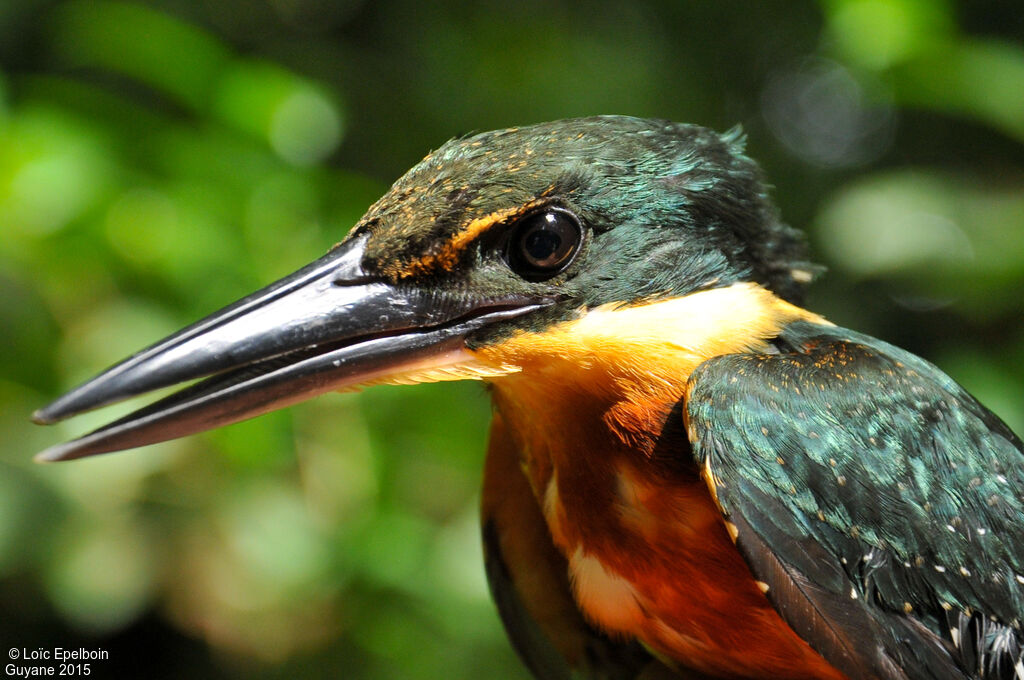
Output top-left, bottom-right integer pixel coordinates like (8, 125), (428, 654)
(506, 210), (583, 281)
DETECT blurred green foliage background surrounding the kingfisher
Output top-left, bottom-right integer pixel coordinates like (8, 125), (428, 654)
(0, 0), (1024, 678)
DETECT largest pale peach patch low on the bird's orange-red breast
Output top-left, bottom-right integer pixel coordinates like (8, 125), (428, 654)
(569, 548), (645, 631)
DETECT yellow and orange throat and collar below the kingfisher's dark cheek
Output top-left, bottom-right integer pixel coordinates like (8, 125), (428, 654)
(471, 283), (827, 460)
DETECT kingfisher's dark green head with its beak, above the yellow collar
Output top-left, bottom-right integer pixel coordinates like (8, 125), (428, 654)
(29, 117), (813, 461)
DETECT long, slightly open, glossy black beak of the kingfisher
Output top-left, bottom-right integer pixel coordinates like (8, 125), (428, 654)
(33, 237), (553, 461)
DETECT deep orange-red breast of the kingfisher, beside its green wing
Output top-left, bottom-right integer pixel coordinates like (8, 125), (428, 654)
(495, 388), (844, 680)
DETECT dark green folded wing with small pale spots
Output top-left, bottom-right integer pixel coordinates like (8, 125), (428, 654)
(686, 323), (1024, 680)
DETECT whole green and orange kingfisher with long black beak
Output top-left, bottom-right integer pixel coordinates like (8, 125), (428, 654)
(35, 116), (1024, 680)
